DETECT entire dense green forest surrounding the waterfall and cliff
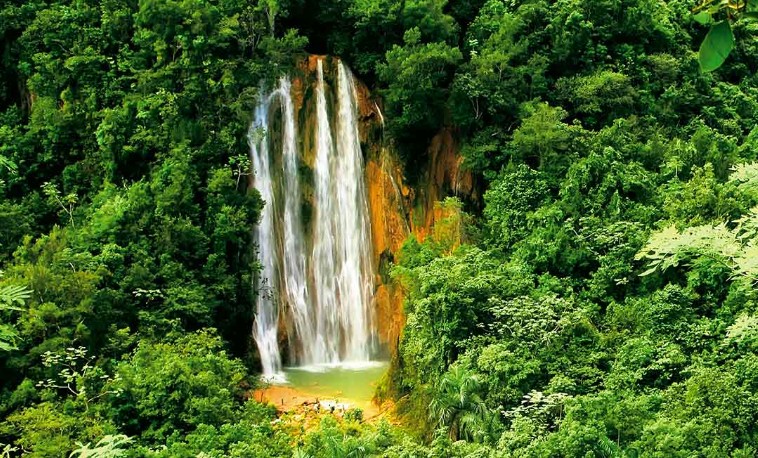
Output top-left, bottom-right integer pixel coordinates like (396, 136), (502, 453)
(0, 0), (758, 457)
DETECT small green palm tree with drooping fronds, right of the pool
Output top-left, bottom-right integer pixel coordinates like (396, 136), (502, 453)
(429, 365), (490, 440)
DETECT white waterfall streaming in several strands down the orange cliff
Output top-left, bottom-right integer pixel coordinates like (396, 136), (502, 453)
(250, 60), (374, 379)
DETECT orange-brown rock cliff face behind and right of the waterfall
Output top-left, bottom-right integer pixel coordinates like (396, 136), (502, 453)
(282, 56), (476, 351)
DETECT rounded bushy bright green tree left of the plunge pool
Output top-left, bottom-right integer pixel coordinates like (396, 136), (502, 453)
(108, 331), (245, 444)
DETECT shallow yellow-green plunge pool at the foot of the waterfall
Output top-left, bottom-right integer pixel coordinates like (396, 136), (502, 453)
(267, 361), (389, 410)
